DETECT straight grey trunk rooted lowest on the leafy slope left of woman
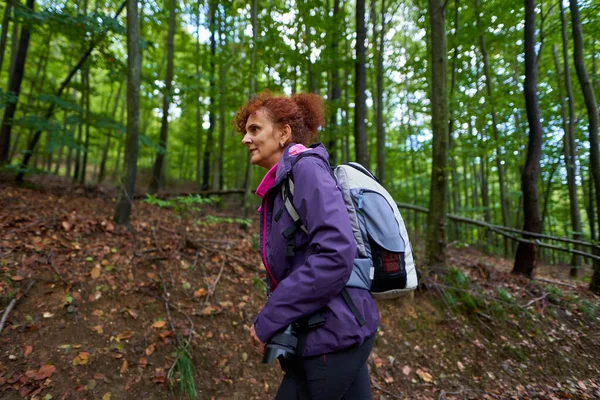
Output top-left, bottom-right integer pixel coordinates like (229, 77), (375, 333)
(114, 0), (141, 226)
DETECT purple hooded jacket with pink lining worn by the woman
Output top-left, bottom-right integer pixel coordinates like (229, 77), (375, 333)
(254, 144), (379, 357)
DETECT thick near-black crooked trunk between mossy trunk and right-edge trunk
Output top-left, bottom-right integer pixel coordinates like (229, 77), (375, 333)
(512, 0), (542, 278)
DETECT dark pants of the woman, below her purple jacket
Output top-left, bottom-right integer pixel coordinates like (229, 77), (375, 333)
(275, 335), (375, 400)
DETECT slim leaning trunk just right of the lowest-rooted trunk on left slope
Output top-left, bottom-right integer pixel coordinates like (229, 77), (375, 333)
(148, 0), (176, 193)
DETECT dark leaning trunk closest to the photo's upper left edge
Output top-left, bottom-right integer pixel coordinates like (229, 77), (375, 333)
(0, 0), (34, 166)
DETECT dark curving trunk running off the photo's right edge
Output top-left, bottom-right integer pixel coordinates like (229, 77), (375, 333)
(570, 0), (600, 294)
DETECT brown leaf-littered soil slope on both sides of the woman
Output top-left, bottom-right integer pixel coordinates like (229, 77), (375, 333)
(0, 177), (600, 400)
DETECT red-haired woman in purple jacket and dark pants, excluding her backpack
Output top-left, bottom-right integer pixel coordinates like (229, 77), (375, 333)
(234, 91), (379, 400)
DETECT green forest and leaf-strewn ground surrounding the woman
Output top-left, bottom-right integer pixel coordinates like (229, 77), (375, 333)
(0, 0), (600, 399)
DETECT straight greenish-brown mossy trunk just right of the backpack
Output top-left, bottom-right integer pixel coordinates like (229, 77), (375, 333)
(426, 0), (448, 265)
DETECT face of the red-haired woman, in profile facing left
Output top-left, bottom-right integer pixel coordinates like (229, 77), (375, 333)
(242, 109), (287, 169)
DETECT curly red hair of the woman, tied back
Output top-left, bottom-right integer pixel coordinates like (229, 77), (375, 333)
(232, 90), (325, 145)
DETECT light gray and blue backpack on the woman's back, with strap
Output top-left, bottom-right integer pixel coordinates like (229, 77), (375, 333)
(281, 162), (417, 300)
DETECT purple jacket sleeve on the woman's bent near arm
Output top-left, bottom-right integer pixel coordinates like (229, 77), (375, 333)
(254, 157), (356, 342)
